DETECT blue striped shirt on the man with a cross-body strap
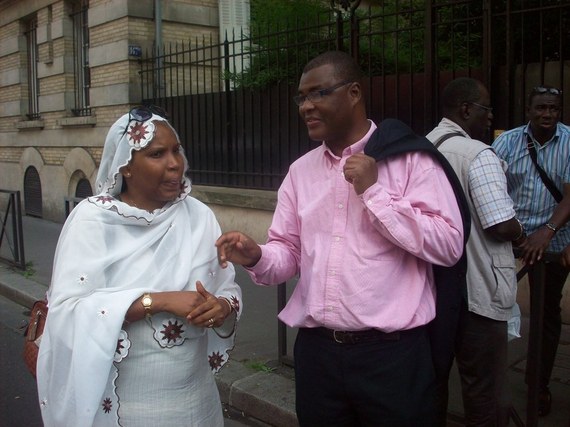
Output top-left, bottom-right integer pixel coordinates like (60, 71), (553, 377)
(493, 123), (570, 252)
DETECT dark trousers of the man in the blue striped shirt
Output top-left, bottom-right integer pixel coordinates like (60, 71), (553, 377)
(529, 262), (570, 388)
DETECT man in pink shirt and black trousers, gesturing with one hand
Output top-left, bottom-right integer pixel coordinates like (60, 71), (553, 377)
(216, 51), (463, 427)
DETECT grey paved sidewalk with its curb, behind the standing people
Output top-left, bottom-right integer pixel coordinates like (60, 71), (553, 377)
(0, 217), (570, 427)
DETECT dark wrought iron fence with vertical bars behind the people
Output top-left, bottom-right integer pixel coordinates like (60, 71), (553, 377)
(140, 0), (570, 189)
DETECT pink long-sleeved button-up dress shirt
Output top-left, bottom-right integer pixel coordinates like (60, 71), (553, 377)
(248, 122), (463, 332)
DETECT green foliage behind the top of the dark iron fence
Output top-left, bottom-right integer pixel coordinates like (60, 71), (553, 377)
(224, 0), (483, 89)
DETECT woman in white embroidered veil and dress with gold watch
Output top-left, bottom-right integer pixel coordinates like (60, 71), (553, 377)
(37, 107), (242, 427)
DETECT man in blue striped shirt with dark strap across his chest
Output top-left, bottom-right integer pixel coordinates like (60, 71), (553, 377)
(492, 86), (570, 416)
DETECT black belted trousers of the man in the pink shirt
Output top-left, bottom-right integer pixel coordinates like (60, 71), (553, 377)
(294, 327), (435, 427)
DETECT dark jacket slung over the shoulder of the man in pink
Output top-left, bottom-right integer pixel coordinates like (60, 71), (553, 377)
(364, 119), (471, 377)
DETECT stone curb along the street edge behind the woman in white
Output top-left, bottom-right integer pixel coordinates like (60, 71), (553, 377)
(0, 264), (299, 427)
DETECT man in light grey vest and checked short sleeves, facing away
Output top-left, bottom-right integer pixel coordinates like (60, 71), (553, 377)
(427, 77), (525, 426)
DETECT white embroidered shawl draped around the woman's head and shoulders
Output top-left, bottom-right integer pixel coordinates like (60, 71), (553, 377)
(37, 115), (242, 427)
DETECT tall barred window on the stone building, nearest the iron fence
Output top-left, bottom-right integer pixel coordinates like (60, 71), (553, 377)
(71, 0), (91, 116)
